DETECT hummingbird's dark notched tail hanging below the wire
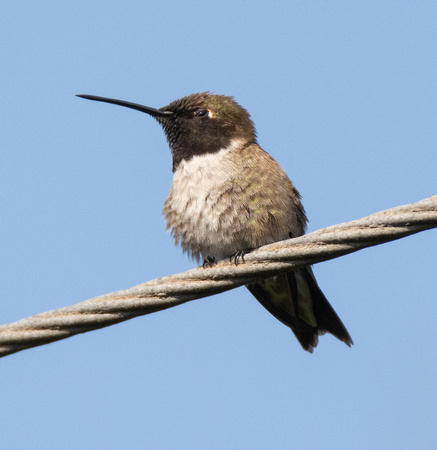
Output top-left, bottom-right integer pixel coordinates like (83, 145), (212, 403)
(246, 267), (353, 353)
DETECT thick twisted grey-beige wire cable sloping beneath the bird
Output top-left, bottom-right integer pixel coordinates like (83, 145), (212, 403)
(0, 195), (437, 357)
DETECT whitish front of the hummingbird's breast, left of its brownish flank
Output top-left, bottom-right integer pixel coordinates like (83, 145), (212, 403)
(164, 140), (244, 260)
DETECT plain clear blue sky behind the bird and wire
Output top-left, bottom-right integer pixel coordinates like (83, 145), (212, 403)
(0, 0), (437, 449)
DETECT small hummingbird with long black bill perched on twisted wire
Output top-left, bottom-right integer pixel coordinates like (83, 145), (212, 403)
(78, 92), (353, 353)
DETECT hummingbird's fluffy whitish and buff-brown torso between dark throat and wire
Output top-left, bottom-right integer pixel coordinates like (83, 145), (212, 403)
(163, 145), (304, 260)
